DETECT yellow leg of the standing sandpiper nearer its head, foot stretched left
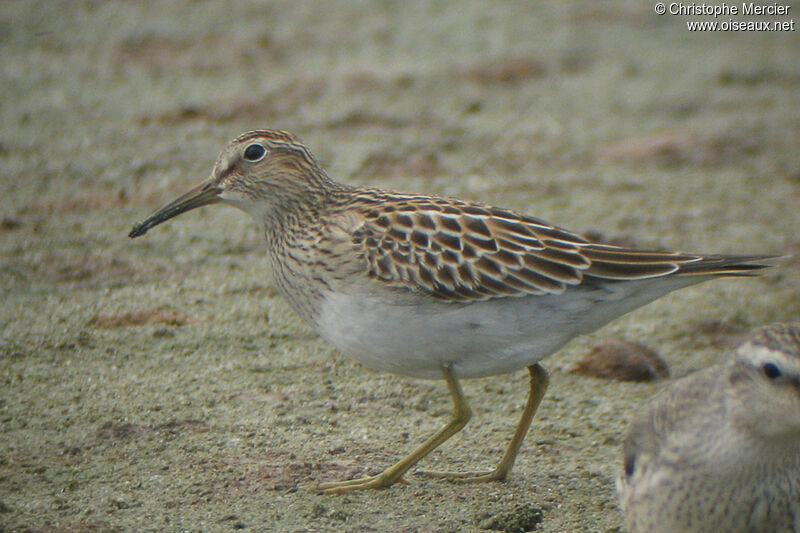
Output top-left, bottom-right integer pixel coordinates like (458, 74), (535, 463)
(309, 365), (472, 493)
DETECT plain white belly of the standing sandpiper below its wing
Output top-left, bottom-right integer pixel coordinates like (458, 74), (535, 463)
(316, 278), (701, 379)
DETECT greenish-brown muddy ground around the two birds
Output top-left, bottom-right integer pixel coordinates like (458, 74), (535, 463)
(0, 0), (800, 532)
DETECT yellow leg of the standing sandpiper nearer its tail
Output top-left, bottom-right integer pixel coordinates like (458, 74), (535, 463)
(417, 363), (550, 482)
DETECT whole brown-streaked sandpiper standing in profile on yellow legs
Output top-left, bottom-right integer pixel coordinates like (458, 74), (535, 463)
(129, 129), (773, 493)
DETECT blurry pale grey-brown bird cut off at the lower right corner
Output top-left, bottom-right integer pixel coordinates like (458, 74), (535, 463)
(617, 322), (800, 533)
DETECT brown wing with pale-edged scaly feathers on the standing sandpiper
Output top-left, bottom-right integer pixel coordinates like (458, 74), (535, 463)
(354, 190), (776, 301)
